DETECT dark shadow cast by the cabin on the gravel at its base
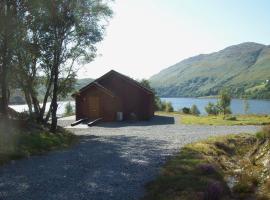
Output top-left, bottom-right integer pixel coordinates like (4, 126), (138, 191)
(96, 116), (175, 128)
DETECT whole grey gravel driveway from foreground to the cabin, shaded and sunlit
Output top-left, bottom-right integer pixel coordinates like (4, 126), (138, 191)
(0, 116), (259, 200)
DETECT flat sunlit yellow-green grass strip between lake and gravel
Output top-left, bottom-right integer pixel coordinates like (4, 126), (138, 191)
(180, 115), (270, 125)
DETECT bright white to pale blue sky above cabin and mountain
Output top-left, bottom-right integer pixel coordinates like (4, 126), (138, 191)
(78, 0), (270, 79)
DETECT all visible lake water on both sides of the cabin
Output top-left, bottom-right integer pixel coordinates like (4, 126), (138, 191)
(10, 98), (270, 116)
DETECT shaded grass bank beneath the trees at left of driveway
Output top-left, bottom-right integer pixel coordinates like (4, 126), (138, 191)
(0, 119), (76, 165)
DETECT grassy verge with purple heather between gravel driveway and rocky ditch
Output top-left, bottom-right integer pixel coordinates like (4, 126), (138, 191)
(145, 135), (255, 200)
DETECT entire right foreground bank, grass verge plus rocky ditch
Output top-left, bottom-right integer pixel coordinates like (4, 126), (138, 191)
(144, 130), (270, 200)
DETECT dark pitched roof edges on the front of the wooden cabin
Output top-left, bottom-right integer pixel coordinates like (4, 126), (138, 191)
(72, 70), (154, 96)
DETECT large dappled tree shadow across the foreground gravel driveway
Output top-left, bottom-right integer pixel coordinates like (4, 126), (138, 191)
(0, 136), (172, 200)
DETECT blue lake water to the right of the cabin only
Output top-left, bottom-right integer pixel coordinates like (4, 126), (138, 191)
(161, 98), (270, 114)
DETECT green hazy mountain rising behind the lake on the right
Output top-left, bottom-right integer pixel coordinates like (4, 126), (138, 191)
(149, 42), (270, 98)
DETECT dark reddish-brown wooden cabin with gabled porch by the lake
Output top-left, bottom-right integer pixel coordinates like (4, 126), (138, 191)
(73, 70), (154, 121)
